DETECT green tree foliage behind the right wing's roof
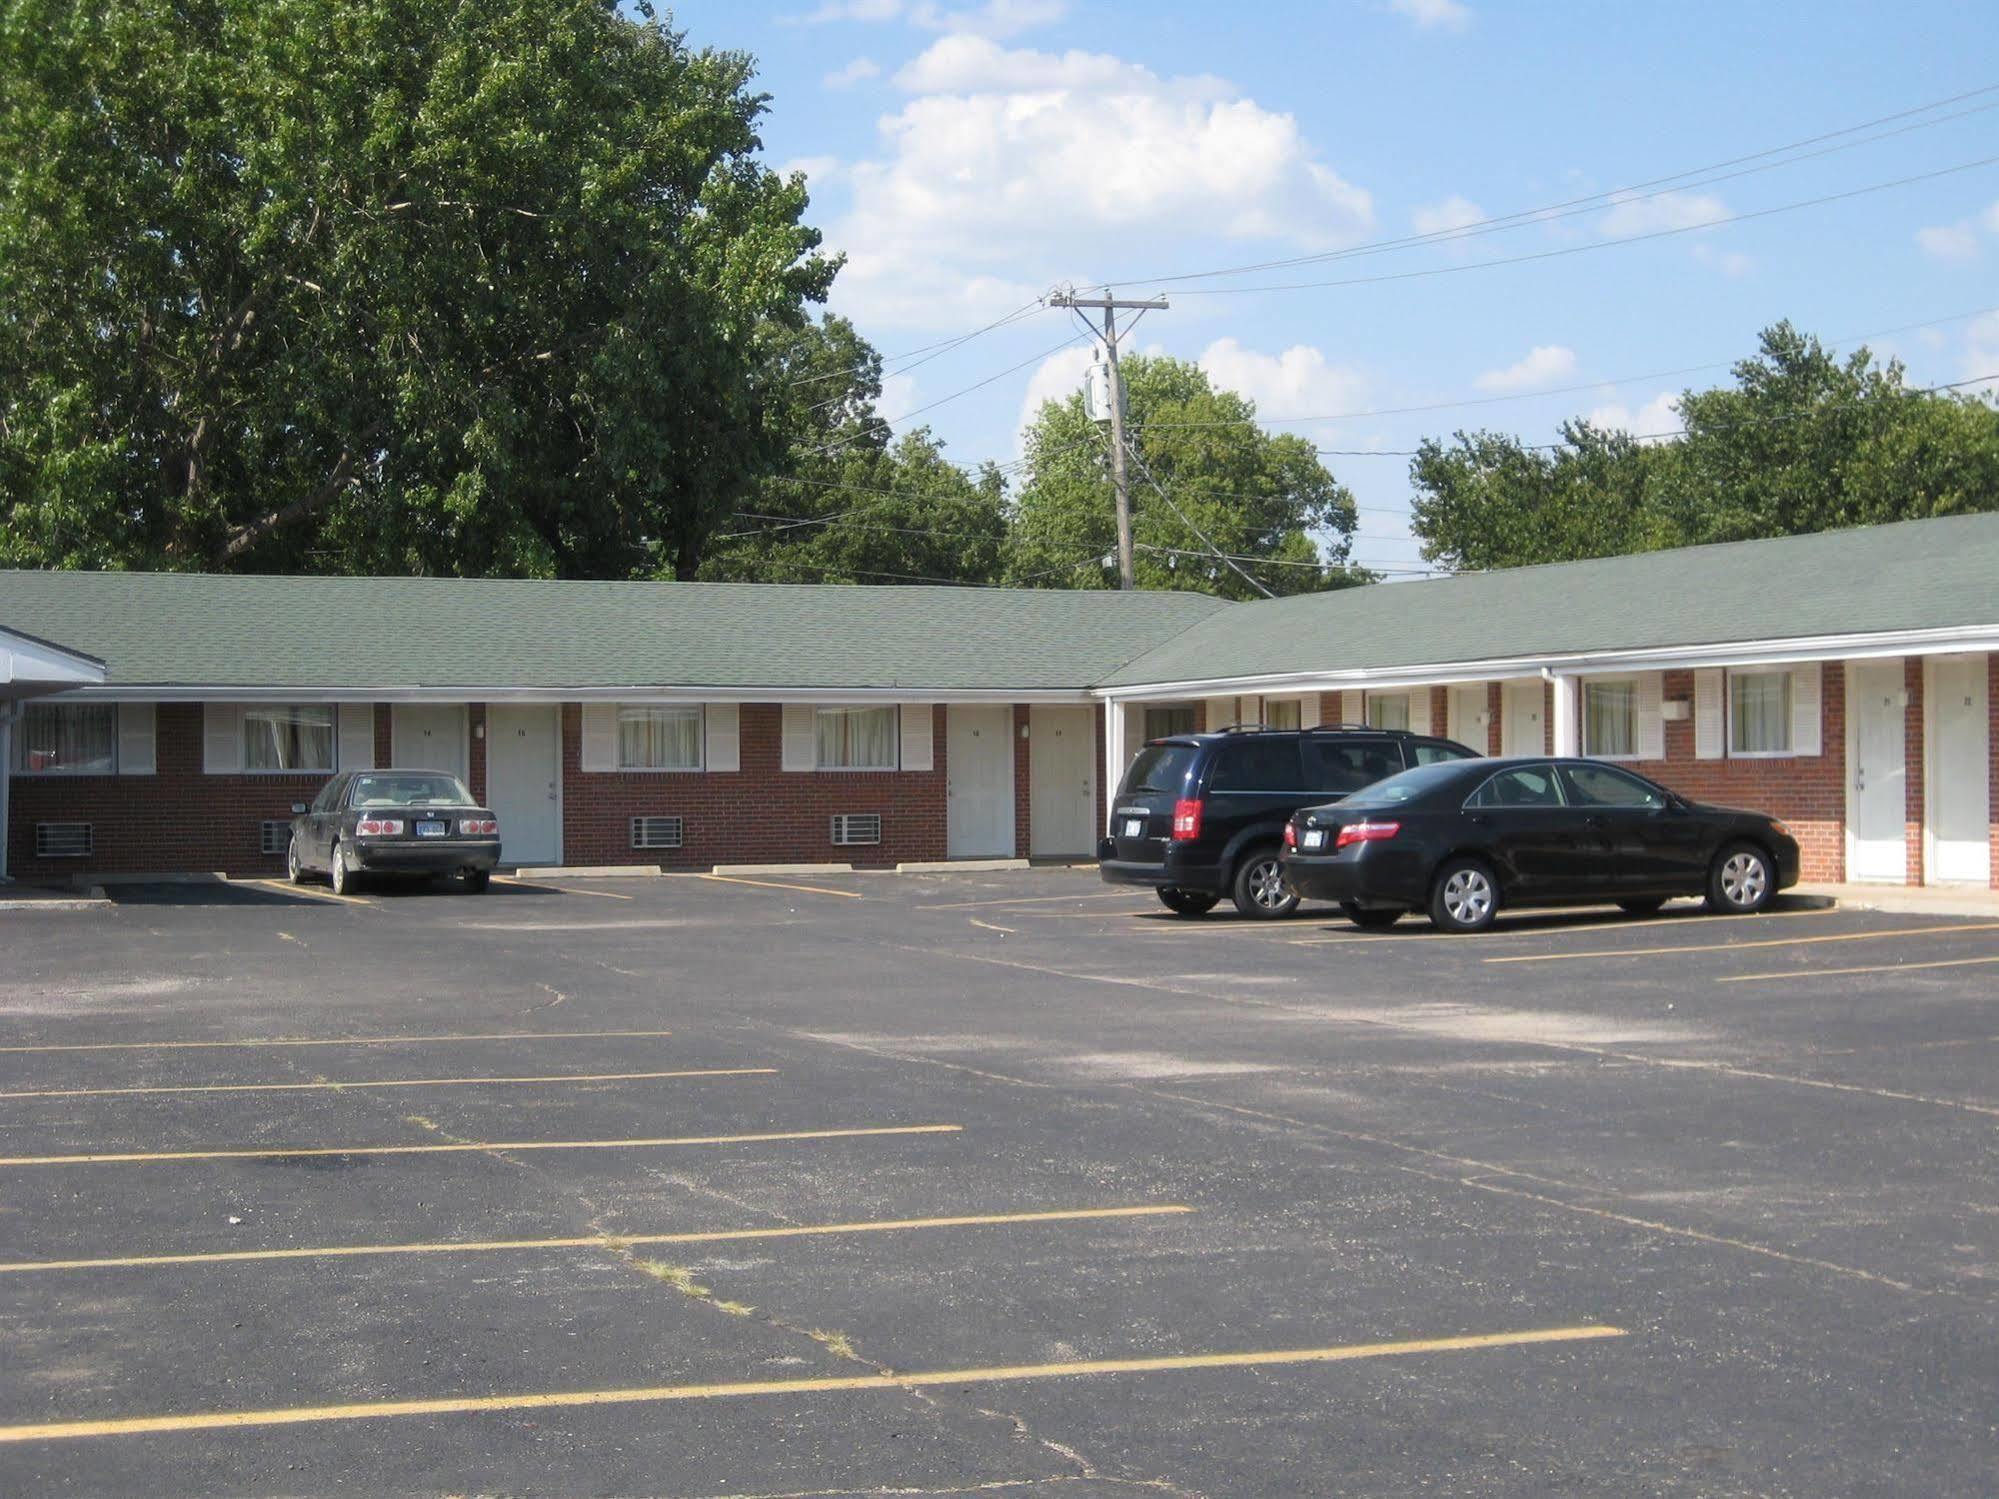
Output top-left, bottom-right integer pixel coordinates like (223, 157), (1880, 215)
(1409, 324), (1999, 568)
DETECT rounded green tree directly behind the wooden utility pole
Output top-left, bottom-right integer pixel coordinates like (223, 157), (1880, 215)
(1005, 356), (1369, 598)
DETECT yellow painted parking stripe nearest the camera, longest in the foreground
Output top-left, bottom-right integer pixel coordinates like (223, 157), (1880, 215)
(0, 1325), (1625, 1443)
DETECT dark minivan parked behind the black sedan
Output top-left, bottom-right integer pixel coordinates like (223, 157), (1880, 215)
(1097, 726), (1477, 917)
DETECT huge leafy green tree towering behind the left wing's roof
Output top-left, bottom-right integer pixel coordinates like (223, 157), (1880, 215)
(0, 0), (834, 576)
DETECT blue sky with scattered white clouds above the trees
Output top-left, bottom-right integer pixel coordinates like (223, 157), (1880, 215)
(674, 0), (1999, 568)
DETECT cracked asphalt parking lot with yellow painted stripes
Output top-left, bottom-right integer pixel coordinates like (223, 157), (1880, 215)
(0, 869), (1999, 1499)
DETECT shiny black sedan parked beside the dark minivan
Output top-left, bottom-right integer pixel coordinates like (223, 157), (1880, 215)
(1283, 757), (1797, 931)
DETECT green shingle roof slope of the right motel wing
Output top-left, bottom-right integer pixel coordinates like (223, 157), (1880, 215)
(1099, 514), (1999, 686)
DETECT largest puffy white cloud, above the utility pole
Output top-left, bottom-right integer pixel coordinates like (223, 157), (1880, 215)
(828, 36), (1373, 328)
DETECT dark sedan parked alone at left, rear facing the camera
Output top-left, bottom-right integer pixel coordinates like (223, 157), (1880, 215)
(284, 769), (500, 895)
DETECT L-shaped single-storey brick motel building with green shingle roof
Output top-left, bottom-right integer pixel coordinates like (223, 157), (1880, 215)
(0, 514), (1999, 887)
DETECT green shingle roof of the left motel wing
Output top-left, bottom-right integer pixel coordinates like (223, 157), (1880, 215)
(0, 572), (1227, 692)
